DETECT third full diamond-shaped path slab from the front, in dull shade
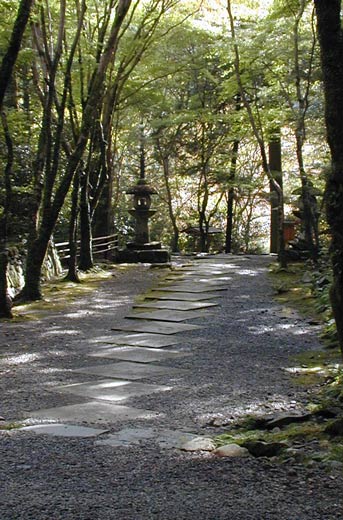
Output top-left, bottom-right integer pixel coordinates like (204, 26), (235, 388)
(73, 361), (188, 380)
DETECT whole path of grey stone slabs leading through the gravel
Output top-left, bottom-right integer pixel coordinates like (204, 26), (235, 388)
(21, 257), (234, 449)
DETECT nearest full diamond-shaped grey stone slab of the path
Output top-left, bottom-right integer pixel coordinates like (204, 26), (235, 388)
(30, 400), (159, 424)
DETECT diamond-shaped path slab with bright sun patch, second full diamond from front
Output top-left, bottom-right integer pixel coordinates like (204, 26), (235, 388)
(49, 379), (171, 401)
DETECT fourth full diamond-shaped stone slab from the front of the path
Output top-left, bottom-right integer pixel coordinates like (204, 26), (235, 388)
(88, 347), (190, 363)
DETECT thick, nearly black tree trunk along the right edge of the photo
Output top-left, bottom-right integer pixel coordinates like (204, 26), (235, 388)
(314, 0), (343, 354)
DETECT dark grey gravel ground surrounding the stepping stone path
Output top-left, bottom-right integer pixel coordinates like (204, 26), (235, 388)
(0, 256), (343, 520)
